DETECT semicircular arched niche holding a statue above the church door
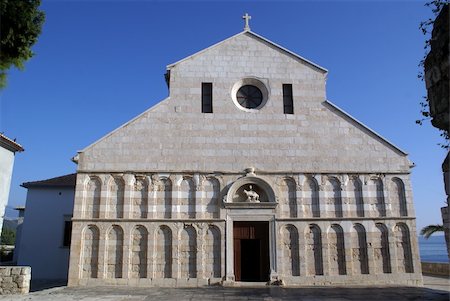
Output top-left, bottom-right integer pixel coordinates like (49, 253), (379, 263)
(224, 176), (277, 207)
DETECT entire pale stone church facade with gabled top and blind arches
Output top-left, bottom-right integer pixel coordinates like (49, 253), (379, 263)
(69, 19), (422, 286)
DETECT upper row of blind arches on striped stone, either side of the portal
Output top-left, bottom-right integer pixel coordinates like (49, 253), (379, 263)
(73, 173), (415, 224)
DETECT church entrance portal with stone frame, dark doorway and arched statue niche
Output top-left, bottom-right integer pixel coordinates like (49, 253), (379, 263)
(224, 173), (277, 282)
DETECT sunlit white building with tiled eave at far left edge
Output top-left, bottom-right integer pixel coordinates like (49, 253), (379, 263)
(0, 134), (23, 233)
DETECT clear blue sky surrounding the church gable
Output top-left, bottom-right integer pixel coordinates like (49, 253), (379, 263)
(0, 1), (445, 232)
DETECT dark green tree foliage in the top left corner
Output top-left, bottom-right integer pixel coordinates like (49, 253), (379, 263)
(0, 0), (45, 89)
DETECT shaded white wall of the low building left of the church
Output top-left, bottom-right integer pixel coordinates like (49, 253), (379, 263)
(17, 187), (75, 279)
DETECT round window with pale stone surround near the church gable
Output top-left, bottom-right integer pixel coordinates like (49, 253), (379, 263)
(231, 78), (269, 112)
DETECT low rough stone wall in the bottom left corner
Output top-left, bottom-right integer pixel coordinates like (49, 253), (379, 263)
(0, 266), (31, 295)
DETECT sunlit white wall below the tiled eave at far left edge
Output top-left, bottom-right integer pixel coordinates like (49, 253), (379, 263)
(0, 147), (14, 233)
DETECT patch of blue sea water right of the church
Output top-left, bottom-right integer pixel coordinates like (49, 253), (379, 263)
(419, 235), (449, 262)
